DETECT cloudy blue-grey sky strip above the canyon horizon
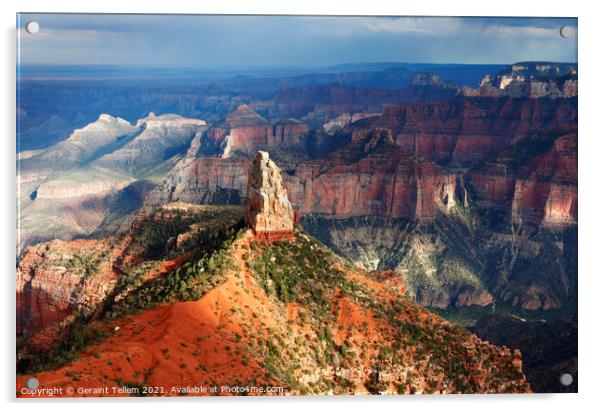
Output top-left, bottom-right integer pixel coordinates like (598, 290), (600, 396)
(17, 14), (577, 68)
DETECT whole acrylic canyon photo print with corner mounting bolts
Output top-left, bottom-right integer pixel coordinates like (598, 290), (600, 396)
(16, 14), (577, 398)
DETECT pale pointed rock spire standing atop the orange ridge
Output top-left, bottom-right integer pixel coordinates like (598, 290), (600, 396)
(245, 151), (294, 241)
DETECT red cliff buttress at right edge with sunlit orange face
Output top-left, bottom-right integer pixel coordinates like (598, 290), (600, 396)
(468, 133), (577, 228)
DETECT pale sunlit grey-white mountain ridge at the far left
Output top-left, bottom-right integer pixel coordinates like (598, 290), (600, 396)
(17, 114), (206, 252)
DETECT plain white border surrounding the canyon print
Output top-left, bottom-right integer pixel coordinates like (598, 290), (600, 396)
(0, 0), (602, 411)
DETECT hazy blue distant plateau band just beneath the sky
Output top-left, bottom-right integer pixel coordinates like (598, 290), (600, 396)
(17, 63), (501, 151)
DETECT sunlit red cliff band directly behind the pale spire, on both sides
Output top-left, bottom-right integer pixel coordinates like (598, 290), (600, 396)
(149, 130), (456, 224)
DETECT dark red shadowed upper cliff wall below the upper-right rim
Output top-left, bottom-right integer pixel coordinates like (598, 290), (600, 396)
(353, 98), (577, 167)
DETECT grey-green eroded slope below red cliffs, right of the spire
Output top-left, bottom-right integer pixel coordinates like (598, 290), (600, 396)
(301, 215), (493, 308)
